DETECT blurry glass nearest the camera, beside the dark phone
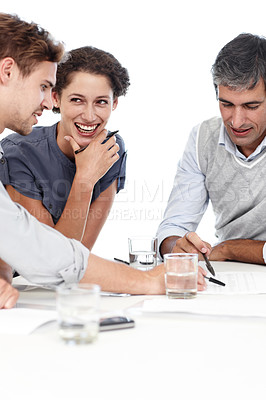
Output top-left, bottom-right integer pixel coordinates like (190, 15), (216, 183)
(56, 283), (100, 344)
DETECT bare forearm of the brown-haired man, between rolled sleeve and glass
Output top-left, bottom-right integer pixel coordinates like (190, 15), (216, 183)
(81, 254), (165, 294)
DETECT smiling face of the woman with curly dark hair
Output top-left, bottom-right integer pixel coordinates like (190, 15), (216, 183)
(53, 72), (117, 147)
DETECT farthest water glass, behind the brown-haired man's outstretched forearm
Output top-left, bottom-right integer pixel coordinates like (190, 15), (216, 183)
(128, 236), (158, 271)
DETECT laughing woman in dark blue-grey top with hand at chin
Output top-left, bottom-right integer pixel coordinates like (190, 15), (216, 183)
(0, 46), (129, 250)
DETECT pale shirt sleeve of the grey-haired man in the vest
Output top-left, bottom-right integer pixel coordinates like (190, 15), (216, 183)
(157, 123), (209, 252)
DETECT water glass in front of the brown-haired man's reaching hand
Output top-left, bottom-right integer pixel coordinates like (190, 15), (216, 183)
(164, 253), (198, 299)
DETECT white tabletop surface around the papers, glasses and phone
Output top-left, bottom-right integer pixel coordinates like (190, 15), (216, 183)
(0, 262), (266, 400)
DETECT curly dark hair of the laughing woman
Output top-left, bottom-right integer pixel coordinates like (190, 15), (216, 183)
(53, 46), (130, 113)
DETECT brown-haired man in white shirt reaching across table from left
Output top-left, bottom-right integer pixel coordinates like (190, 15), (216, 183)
(0, 13), (208, 308)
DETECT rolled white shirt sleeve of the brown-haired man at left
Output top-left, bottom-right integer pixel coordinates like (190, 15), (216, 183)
(0, 183), (90, 284)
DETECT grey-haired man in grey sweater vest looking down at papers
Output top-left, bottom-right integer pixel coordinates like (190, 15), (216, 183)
(157, 33), (266, 264)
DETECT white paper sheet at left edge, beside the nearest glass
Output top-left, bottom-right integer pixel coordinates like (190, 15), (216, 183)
(0, 308), (57, 335)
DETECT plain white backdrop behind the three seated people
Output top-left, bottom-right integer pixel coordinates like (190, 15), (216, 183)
(1, 0), (266, 258)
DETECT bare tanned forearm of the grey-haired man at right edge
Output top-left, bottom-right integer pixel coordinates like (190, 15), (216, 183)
(210, 239), (265, 264)
